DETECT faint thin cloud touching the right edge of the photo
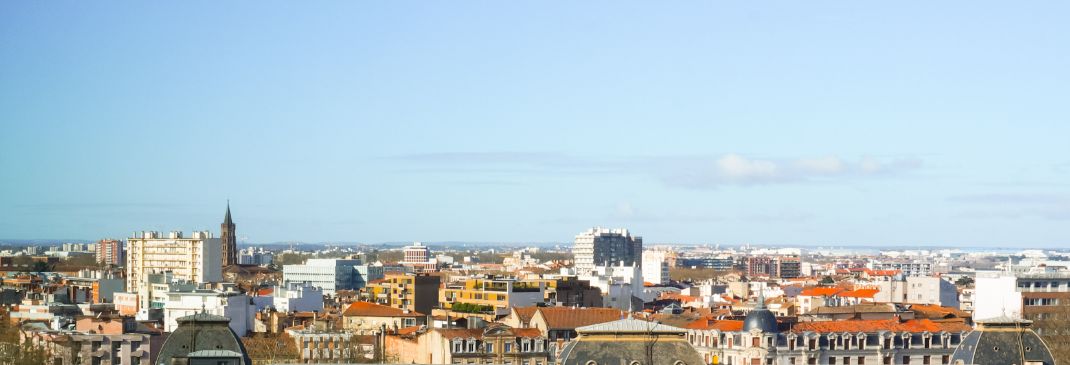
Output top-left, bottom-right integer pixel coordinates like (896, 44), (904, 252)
(948, 193), (1070, 220)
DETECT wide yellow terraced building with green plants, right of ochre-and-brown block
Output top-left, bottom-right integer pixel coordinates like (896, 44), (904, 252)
(439, 278), (546, 316)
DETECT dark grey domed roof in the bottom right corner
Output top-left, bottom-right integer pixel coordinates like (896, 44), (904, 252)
(951, 317), (1055, 365)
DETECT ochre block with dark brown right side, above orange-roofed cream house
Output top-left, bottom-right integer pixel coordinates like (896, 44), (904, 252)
(361, 273), (441, 314)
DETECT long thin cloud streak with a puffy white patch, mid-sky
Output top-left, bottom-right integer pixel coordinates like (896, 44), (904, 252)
(388, 152), (921, 188)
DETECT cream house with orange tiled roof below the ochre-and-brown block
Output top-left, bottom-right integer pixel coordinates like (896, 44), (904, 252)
(341, 302), (427, 335)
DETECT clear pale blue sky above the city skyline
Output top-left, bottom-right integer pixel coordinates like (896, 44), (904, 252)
(0, 1), (1070, 247)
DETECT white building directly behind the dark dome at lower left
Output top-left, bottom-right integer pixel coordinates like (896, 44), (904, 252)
(164, 286), (257, 336)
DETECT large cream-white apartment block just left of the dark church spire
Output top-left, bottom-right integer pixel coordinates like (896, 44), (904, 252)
(126, 231), (223, 288)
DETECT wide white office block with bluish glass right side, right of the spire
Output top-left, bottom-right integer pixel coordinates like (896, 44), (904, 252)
(282, 259), (383, 295)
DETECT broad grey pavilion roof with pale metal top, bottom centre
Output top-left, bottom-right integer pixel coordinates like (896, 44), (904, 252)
(557, 318), (705, 365)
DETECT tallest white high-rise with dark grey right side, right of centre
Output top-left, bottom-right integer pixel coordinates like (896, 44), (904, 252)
(572, 227), (643, 274)
